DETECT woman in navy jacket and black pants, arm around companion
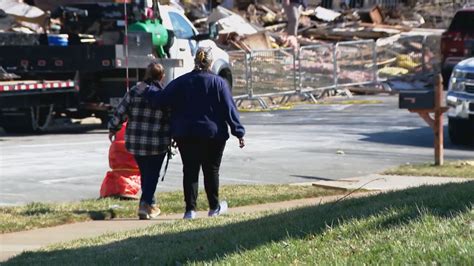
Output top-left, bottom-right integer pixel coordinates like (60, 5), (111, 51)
(146, 48), (245, 219)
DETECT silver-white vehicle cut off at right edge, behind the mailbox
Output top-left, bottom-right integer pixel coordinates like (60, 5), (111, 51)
(446, 57), (474, 144)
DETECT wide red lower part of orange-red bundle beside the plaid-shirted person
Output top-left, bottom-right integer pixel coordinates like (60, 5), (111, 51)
(100, 170), (141, 199)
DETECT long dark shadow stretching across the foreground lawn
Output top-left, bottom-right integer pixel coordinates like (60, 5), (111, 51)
(7, 181), (474, 265)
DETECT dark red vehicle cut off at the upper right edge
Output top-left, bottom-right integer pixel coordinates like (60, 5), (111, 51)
(441, 7), (474, 85)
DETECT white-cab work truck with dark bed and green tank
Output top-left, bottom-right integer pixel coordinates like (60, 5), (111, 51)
(0, 0), (232, 132)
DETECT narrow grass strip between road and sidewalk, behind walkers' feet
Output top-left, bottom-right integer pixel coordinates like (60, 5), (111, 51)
(0, 185), (345, 233)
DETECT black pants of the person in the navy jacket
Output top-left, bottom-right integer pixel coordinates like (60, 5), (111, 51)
(176, 138), (225, 211)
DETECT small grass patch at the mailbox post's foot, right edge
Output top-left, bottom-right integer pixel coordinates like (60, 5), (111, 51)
(383, 159), (474, 178)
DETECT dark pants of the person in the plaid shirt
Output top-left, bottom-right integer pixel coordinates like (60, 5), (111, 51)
(135, 153), (166, 204)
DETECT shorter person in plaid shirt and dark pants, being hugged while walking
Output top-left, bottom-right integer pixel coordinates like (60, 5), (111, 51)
(108, 63), (171, 219)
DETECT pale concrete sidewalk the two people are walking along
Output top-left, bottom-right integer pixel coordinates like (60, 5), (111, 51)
(0, 175), (471, 262)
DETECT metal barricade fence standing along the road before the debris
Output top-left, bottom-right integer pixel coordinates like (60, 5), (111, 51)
(229, 34), (441, 108)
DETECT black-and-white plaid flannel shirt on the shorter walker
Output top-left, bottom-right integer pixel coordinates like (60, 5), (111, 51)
(108, 83), (171, 156)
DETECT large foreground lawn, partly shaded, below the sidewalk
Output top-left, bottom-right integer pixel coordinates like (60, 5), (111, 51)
(6, 181), (474, 265)
